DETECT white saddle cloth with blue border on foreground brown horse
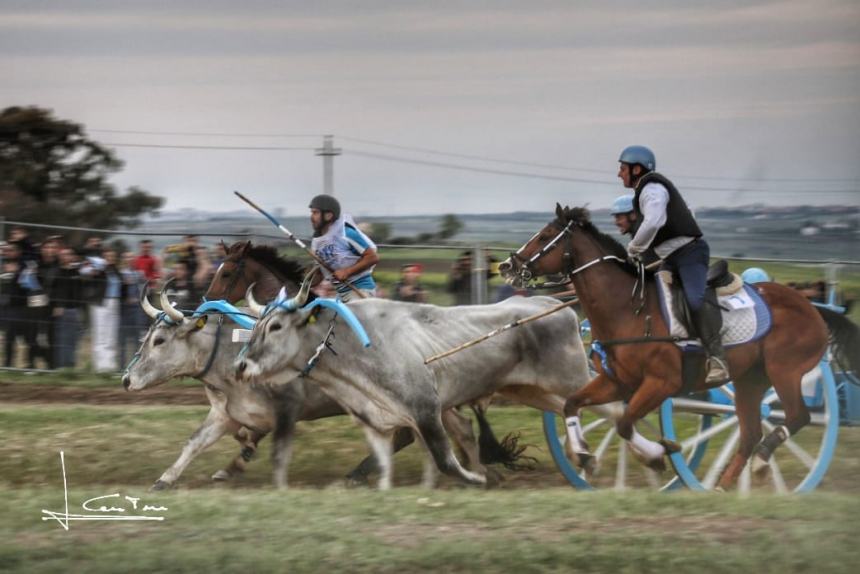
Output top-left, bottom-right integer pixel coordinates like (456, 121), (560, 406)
(655, 271), (772, 350)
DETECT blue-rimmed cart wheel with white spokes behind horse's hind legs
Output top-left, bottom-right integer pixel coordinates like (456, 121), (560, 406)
(660, 356), (839, 492)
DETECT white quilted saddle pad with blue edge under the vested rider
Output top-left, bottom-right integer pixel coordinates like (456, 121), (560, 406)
(657, 280), (771, 347)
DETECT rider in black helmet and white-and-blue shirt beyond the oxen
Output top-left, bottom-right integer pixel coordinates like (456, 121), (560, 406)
(308, 195), (379, 302)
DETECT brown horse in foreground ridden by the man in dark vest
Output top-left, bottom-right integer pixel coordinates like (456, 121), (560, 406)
(499, 204), (860, 489)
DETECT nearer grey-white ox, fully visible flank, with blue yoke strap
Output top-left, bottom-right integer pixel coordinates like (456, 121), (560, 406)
(236, 281), (614, 490)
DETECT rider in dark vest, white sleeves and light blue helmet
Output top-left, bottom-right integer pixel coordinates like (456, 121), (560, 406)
(618, 146), (729, 384)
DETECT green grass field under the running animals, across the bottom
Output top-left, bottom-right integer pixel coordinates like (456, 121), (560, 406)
(0, 403), (860, 573)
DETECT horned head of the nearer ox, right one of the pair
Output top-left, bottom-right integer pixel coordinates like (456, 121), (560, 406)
(234, 267), (317, 380)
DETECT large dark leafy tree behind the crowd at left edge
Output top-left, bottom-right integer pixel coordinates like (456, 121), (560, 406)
(0, 107), (164, 236)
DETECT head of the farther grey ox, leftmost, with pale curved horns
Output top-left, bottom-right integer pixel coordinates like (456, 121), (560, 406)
(122, 290), (217, 391)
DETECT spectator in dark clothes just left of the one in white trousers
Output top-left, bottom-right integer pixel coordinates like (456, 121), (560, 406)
(49, 247), (83, 369)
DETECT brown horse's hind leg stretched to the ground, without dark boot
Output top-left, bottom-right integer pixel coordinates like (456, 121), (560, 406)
(717, 373), (769, 490)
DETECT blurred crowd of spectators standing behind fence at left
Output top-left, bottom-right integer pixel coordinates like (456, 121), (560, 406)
(0, 227), (224, 372)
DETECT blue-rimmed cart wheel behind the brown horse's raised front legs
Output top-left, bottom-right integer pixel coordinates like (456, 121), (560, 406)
(543, 412), (712, 490)
